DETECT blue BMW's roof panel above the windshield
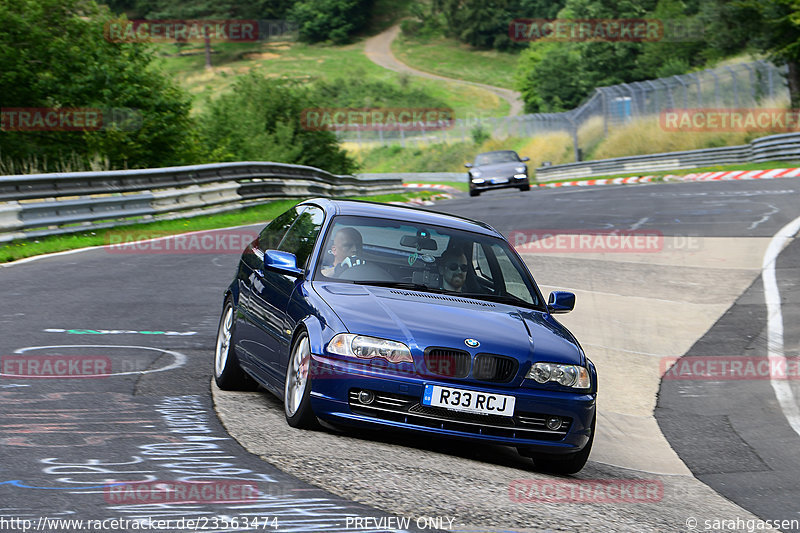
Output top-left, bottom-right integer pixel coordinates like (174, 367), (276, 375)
(303, 198), (503, 238)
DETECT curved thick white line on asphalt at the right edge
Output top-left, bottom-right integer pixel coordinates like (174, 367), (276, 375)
(761, 217), (800, 435)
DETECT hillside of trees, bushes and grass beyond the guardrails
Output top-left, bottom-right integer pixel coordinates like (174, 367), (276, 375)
(0, 0), (800, 172)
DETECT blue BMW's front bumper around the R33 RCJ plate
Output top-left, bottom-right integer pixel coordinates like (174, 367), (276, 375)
(309, 355), (596, 454)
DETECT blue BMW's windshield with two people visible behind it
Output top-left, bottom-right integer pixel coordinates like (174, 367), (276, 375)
(315, 216), (543, 309)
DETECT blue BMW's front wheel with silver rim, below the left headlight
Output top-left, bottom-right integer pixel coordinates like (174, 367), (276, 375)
(283, 331), (319, 429)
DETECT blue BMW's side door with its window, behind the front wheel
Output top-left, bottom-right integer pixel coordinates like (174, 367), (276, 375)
(250, 205), (325, 382)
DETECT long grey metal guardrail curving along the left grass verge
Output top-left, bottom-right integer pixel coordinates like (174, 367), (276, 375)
(0, 162), (403, 242)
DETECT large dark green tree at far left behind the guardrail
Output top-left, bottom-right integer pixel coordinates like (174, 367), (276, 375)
(0, 0), (196, 171)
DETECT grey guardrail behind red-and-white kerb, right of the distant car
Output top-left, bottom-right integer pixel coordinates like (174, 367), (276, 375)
(536, 133), (800, 181)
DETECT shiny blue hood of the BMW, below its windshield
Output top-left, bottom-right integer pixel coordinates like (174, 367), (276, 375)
(314, 282), (585, 364)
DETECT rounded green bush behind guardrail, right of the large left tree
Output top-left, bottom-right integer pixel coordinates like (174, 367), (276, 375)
(200, 72), (356, 174)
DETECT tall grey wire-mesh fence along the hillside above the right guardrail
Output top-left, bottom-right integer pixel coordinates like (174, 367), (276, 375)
(337, 60), (789, 160)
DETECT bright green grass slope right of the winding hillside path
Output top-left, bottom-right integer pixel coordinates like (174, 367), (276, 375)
(392, 34), (519, 89)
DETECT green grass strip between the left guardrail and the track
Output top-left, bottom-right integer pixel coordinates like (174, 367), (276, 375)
(0, 191), (437, 263)
